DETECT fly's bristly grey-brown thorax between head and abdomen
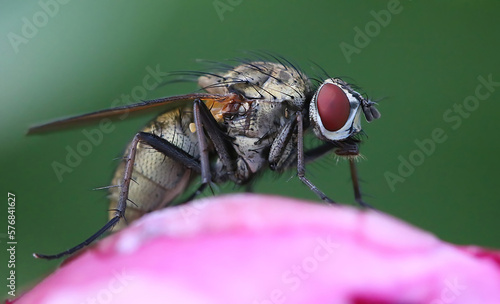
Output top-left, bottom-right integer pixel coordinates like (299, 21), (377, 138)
(198, 61), (312, 183)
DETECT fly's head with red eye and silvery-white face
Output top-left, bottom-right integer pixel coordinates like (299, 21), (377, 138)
(309, 78), (380, 142)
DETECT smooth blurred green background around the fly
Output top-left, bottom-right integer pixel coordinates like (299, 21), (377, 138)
(0, 0), (500, 295)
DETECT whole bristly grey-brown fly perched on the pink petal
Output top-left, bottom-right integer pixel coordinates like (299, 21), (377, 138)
(29, 57), (380, 259)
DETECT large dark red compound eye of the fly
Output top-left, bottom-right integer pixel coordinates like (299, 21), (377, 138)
(316, 83), (351, 132)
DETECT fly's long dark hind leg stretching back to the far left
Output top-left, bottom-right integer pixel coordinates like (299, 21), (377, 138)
(33, 132), (201, 260)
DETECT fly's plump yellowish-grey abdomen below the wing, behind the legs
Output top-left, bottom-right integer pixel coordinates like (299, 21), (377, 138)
(110, 108), (200, 226)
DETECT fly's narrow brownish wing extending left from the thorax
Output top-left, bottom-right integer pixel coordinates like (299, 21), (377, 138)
(28, 93), (232, 135)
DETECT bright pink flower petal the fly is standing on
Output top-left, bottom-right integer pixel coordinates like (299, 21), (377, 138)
(9, 194), (500, 304)
